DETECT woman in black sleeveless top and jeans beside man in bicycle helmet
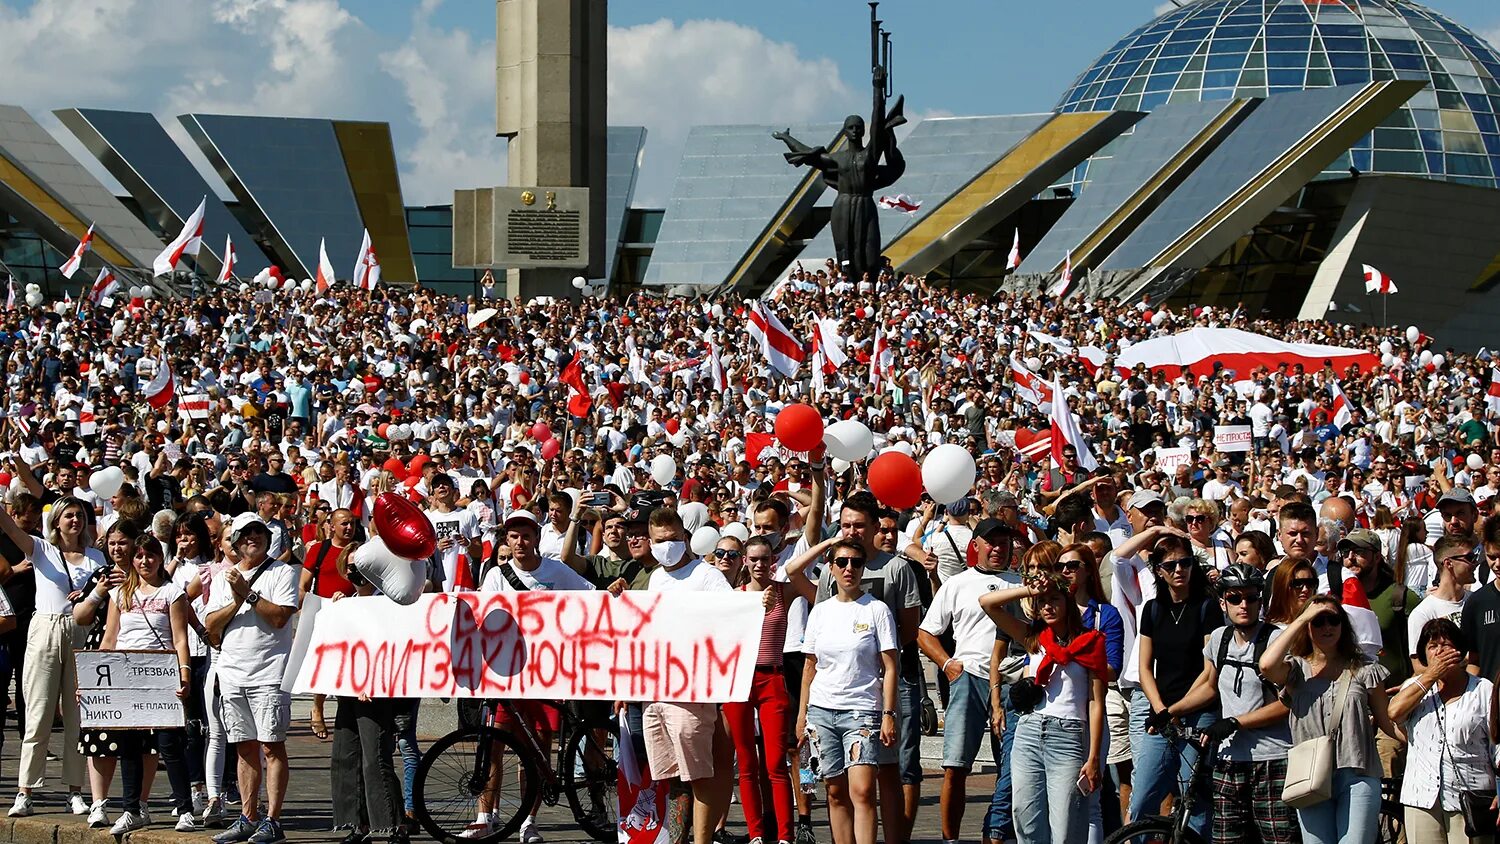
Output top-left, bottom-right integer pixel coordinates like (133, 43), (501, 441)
(1130, 534), (1224, 838)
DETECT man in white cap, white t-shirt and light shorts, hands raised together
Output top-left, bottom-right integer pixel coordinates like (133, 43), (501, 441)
(207, 513), (299, 844)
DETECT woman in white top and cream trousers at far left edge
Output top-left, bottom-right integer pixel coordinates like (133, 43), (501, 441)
(0, 495), (105, 817)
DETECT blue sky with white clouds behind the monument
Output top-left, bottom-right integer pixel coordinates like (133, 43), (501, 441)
(0, 0), (1500, 207)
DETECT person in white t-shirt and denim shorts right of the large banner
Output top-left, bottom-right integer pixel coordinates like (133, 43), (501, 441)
(797, 540), (899, 844)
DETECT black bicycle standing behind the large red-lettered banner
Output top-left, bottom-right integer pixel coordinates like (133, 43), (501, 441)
(411, 700), (620, 844)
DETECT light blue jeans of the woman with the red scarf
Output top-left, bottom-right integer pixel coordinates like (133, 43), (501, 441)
(1011, 712), (1089, 844)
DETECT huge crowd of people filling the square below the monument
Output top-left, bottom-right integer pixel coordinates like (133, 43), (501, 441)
(0, 257), (1500, 844)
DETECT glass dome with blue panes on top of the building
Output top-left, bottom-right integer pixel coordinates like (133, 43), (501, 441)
(1058, 0), (1500, 189)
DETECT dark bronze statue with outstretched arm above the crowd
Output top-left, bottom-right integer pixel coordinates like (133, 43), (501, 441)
(771, 3), (906, 280)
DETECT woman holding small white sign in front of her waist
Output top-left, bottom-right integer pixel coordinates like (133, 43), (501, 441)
(101, 535), (192, 835)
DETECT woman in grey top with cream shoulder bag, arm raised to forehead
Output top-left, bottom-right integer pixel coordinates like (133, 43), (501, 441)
(1260, 595), (1400, 844)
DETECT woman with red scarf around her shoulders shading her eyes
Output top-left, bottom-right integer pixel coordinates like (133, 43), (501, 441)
(980, 573), (1110, 844)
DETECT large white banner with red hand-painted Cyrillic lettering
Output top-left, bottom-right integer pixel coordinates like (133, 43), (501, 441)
(293, 592), (765, 703)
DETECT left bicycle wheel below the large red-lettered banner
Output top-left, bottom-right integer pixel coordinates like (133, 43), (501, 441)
(411, 727), (542, 844)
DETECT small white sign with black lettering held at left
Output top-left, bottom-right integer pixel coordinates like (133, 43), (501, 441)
(75, 651), (186, 729)
